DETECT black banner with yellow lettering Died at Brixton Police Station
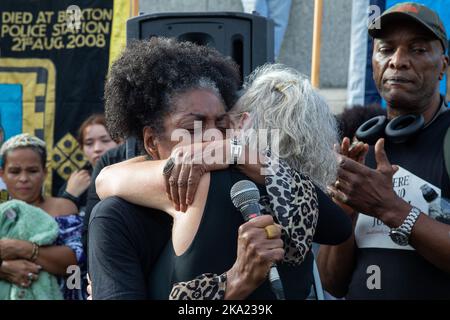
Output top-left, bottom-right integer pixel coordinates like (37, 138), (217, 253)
(0, 0), (130, 194)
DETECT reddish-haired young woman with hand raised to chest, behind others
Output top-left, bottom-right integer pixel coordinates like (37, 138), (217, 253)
(58, 114), (117, 212)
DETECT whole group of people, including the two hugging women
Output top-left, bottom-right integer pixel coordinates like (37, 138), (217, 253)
(0, 3), (450, 300)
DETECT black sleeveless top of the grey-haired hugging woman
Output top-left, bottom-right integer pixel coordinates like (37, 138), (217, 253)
(148, 169), (313, 300)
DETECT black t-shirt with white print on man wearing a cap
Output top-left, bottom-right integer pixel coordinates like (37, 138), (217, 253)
(347, 111), (450, 299)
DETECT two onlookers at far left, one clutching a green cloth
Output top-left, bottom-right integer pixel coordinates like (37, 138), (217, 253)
(0, 114), (117, 300)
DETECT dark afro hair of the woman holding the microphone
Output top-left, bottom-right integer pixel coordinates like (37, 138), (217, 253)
(105, 37), (240, 142)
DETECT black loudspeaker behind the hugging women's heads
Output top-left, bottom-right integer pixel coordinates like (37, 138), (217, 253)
(127, 12), (274, 80)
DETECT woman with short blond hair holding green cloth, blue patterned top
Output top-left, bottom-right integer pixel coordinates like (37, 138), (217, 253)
(0, 133), (86, 299)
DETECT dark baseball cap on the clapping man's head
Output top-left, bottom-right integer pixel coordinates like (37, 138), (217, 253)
(369, 2), (449, 51)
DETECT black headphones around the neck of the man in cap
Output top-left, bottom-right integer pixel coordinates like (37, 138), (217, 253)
(356, 114), (425, 145)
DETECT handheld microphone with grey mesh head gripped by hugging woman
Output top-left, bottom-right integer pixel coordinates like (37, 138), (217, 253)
(230, 180), (285, 300)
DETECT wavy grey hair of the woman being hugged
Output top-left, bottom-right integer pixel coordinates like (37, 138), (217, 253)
(231, 64), (338, 190)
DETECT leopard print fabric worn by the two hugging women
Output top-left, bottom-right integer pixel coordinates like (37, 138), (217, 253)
(169, 158), (319, 300)
